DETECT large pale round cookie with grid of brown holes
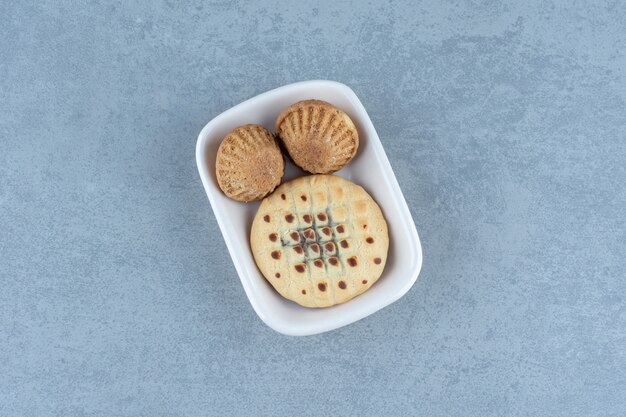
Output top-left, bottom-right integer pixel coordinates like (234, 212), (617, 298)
(250, 175), (389, 307)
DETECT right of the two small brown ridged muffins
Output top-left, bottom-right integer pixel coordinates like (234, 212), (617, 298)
(276, 100), (359, 174)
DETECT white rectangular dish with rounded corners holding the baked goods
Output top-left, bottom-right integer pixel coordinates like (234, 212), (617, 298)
(196, 80), (422, 336)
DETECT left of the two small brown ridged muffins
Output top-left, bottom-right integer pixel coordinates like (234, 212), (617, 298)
(215, 124), (285, 202)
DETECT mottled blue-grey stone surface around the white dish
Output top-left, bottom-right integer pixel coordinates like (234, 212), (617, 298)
(0, 0), (626, 416)
